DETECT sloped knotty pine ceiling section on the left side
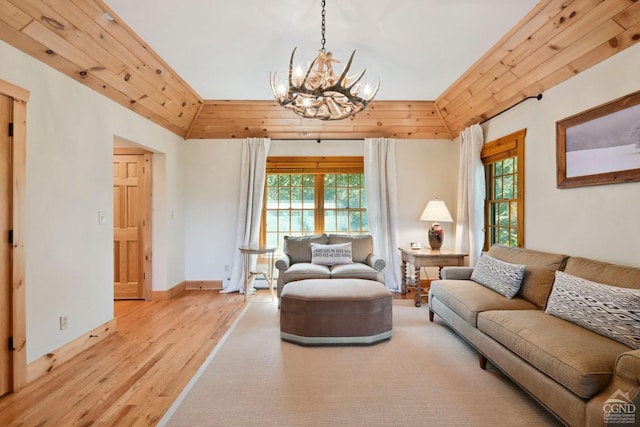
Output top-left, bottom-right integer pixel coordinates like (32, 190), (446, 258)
(0, 0), (203, 137)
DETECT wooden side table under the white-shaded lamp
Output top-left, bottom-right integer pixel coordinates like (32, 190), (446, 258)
(398, 248), (467, 307)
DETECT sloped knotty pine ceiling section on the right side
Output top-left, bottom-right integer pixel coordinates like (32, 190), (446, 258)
(436, 0), (640, 136)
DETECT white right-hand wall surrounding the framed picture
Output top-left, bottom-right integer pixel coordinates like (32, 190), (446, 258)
(484, 41), (640, 267)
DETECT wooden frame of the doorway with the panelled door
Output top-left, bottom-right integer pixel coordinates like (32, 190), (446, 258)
(113, 147), (153, 301)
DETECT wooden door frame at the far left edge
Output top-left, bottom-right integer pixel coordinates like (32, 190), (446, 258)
(0, 80), (30, 392)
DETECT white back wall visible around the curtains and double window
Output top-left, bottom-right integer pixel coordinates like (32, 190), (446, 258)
(185, 140), (458, 280)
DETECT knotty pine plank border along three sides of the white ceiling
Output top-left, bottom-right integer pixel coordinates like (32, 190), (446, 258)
(0, 0), (640, 139)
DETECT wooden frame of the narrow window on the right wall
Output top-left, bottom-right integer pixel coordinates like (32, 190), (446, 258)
(480, 129), (527, 251)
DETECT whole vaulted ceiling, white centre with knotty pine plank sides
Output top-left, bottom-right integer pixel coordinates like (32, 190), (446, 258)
(0, 0), (640, 139)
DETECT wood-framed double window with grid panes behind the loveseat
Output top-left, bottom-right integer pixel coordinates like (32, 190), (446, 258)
(260, 157), (369, 252)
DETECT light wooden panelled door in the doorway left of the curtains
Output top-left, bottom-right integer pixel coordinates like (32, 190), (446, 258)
(113, 148), (151, 299)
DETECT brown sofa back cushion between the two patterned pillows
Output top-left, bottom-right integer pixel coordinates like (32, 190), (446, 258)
(488, 245), (568, 309)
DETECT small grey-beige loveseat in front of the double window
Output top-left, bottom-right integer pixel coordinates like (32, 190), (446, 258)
(276, 234), (386, 298)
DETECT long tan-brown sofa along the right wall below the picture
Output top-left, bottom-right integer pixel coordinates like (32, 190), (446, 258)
(429, 246), (640, 426)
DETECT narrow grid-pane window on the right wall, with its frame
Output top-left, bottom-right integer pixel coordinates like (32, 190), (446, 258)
(481, 130), (526, 250)
